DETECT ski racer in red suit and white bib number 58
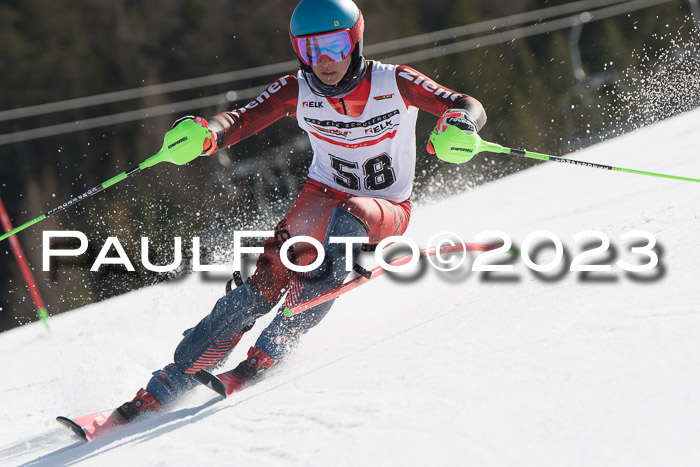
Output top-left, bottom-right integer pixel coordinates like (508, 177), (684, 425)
(119, 0), (486, 420)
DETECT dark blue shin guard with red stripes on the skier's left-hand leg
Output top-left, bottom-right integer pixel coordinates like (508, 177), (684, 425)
(174, 280), (271, 374)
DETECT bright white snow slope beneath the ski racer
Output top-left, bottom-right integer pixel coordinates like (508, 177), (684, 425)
(0, 110), (700, 466)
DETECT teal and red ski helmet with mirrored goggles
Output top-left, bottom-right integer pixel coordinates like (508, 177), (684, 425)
(289, 0), (367, 97)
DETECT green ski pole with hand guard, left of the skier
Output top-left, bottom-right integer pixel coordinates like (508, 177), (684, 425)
(0, 119), (211, 245)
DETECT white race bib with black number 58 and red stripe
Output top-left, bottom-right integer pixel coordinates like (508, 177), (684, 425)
(297, 62), (418, 202)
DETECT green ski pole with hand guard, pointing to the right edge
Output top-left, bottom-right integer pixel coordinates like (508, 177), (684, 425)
(430, 126), (700, 183)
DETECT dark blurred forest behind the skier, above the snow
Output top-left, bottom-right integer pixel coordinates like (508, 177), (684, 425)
(0, 0), (698, 330)
